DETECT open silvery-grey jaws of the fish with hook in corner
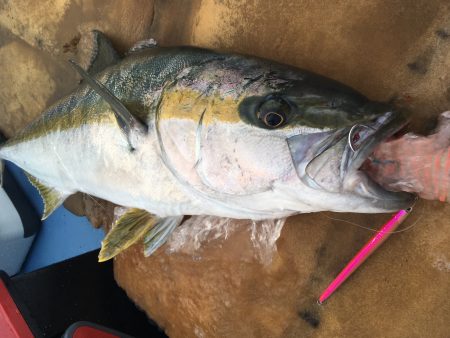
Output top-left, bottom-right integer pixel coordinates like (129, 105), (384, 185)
(287, 112), (416, 212)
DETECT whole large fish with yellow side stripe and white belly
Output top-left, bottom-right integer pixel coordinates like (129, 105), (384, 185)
(0, 33), (414, 260)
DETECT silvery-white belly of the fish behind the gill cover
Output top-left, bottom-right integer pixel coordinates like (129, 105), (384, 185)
(0, 124), (198, 216)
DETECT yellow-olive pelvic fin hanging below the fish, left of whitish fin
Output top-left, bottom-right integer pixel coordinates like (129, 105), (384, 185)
(98, 208), (160, 262)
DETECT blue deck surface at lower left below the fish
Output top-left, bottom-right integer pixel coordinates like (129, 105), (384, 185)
(7, 163), (104, 272)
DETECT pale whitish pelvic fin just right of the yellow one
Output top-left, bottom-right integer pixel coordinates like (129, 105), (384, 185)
(144, 216), (183, 257)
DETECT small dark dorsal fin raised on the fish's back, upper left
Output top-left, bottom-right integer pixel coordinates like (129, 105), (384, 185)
(86, 30), (120, 75)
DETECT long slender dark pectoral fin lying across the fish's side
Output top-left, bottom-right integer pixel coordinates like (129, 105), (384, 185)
(69, 60), (147, 150)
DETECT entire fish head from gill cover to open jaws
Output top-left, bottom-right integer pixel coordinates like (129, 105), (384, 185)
(158, 58), (414, 213)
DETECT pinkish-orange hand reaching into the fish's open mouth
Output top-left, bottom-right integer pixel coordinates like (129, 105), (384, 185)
(363, 111), (450, 202)
